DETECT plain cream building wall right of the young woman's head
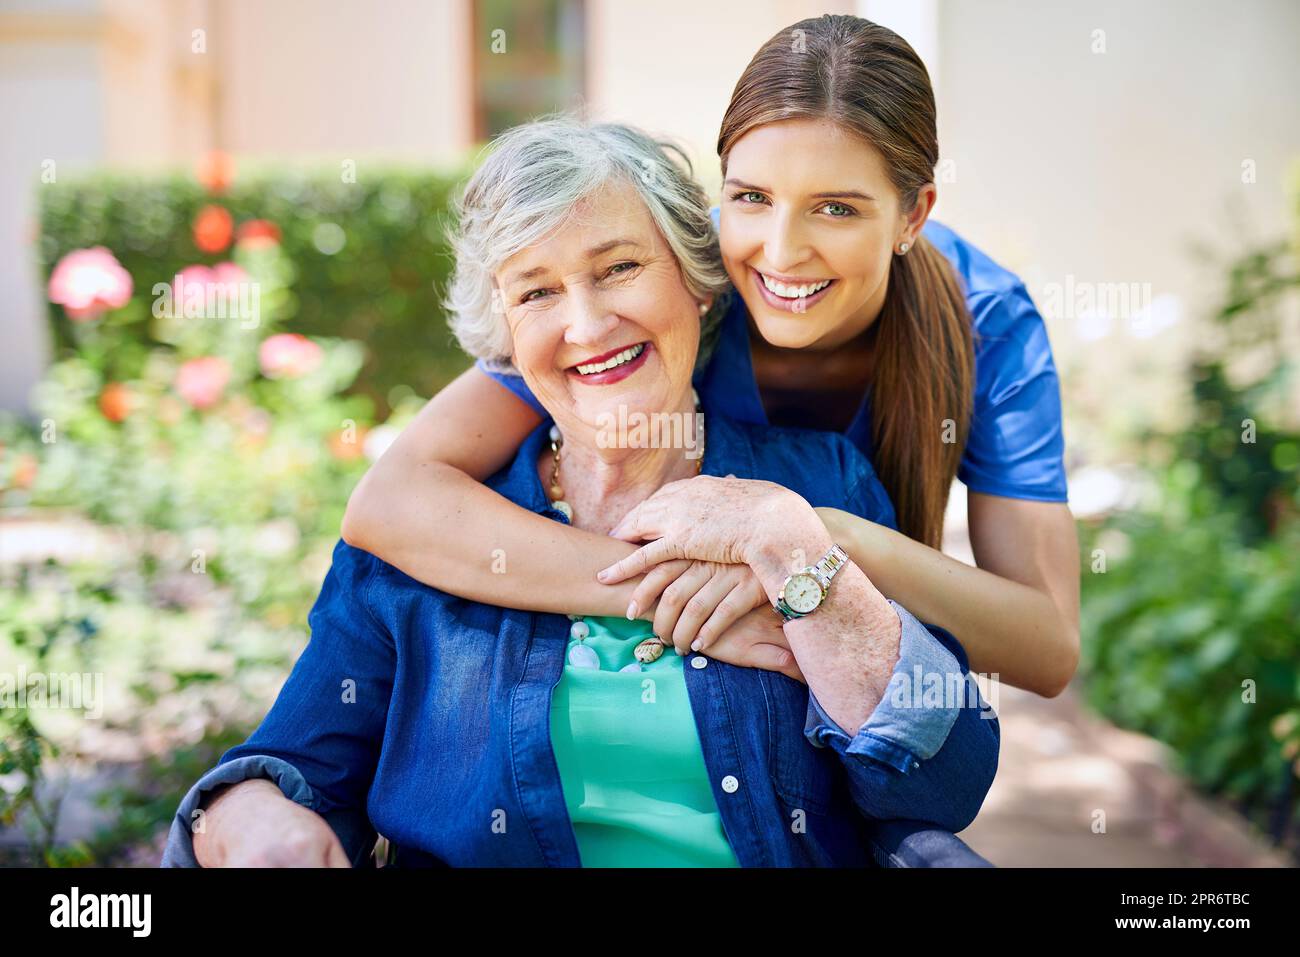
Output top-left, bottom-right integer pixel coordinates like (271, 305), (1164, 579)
(936, 0), (1300, 460)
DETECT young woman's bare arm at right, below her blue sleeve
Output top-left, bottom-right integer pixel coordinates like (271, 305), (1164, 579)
(818, 492), (1079, 697)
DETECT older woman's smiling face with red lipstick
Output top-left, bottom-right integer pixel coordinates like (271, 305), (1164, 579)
(494, 183), (699, 447)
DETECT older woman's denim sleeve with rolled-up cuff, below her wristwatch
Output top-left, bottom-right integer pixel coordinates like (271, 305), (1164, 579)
(803, 602), (1001, 831)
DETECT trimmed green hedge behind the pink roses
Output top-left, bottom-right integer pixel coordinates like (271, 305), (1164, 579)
(38, 166), (478, 413)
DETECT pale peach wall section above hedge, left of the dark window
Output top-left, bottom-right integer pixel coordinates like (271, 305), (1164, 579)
(217, 0), (472, 161)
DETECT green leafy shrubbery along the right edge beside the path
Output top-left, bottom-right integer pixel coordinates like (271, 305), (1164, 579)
(1080, 217), (1300, 839)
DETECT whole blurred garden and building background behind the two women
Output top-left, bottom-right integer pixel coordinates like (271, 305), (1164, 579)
(0, 0), (1300, 866)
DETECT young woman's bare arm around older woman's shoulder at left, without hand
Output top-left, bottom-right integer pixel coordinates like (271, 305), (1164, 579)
(343, 368), (636, 615)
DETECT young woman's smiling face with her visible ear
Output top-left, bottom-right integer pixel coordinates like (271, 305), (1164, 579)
(720, 120), (933, 348)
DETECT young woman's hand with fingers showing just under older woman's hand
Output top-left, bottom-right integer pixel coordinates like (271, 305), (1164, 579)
(628, 559), (775, 654)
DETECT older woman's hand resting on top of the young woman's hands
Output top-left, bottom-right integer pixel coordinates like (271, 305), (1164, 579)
(597, 475), (826, 595)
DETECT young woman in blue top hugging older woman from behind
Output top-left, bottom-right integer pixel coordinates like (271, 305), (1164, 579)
(343, 16), (1079, 696)
